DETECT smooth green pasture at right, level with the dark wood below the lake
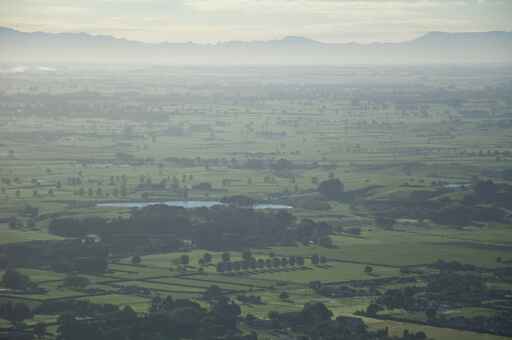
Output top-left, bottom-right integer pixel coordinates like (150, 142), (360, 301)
(272, 227), (512, 267)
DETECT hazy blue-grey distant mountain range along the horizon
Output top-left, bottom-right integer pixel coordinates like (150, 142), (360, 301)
(0, 27), (512, 65)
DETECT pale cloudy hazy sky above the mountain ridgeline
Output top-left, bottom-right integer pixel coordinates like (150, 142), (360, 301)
(0, 0), (512, 42)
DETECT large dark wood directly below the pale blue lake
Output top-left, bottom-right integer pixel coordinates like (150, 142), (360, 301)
(49, 205), (332, 253)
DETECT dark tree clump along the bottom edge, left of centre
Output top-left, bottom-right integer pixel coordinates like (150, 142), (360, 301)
(57, 297), (257, 340)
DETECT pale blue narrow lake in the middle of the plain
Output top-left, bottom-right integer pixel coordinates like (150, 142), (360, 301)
(96, 201), (293, 210)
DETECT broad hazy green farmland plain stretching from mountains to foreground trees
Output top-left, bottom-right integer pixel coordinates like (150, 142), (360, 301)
(0, 66), (512, 340)
